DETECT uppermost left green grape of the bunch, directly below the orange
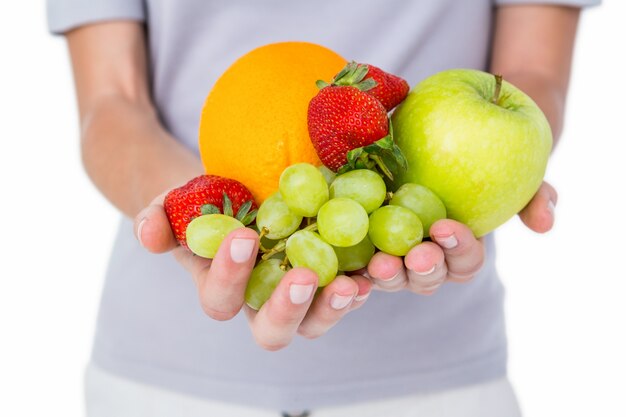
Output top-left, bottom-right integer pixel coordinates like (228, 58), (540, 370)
(278, 163), (328, 217)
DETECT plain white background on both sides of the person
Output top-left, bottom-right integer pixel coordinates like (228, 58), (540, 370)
(0, 0), (626, 417)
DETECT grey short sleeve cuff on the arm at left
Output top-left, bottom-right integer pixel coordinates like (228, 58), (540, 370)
(46, 0), (146, 34)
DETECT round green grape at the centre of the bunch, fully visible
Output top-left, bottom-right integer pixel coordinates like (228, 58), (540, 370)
(317, 198), (369, 247)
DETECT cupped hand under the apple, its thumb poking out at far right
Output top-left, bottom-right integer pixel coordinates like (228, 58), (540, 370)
(366, 182), (557, 295)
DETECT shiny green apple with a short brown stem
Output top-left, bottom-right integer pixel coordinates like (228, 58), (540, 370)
(392, 69), (552, 237)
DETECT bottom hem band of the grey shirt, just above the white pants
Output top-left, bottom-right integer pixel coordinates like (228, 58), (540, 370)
(92, 347), (507, 410)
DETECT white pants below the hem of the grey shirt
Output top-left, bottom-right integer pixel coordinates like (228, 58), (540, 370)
(85, 364), (521, 417)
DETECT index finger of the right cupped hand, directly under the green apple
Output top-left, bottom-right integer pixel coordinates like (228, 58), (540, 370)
(430, 219), (485, 282)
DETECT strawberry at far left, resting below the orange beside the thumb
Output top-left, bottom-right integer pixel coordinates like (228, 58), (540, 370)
(163, 175), (257, 247)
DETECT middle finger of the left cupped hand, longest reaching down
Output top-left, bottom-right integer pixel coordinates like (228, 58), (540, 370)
(246, 268), (318, 351)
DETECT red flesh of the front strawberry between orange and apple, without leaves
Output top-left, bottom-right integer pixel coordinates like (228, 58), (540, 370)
(308, 86), (389, 172)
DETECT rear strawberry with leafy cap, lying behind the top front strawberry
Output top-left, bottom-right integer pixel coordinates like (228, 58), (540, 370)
(318, 61), (409, 111)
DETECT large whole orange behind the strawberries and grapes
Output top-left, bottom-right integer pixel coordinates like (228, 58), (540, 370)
(199, 42), (346, 203)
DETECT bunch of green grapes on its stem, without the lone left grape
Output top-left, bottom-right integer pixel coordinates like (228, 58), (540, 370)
(245, 163), (446, 309)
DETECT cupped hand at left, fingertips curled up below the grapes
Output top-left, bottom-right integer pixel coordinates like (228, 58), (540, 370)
(135, 194), (372, 350)
